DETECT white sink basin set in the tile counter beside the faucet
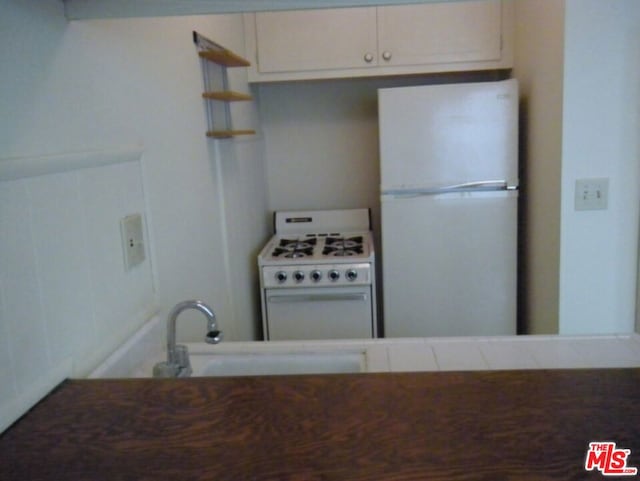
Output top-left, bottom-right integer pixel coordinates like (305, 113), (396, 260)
(191, 352), (365, 377)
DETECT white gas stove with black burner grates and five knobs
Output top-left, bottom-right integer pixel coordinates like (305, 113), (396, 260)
(258, 209), (377, 340)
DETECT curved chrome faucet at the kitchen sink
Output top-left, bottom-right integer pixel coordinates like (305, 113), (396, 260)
(153, 300), (222, 377)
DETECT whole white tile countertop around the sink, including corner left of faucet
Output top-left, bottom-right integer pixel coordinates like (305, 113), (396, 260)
(89, 317), (640, 378)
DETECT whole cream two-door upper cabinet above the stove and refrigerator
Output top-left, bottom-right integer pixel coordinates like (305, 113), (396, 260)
(244, 0), (513, 82)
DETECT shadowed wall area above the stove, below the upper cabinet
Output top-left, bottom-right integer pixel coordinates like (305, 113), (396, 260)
(259, 80), (379, 234)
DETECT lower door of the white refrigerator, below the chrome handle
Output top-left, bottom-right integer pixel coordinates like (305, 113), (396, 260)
(382, 191), (518, 337)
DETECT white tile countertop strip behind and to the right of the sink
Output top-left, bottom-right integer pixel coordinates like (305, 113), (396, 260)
(178, 334), (640, 372)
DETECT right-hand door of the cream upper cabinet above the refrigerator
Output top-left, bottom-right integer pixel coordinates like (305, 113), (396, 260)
(378, 0), (502, 66)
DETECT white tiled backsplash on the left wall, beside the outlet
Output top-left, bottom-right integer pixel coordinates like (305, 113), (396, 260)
(0, 151), (156, 431)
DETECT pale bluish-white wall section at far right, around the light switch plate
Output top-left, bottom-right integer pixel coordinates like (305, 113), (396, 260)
(560, 0), (640, 334)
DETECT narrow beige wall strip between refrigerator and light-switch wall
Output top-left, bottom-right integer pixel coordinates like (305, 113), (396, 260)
(514, 0), (564, 334)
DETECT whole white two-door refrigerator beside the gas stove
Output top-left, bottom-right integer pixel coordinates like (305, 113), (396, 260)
(378, 79), (518, 337)
